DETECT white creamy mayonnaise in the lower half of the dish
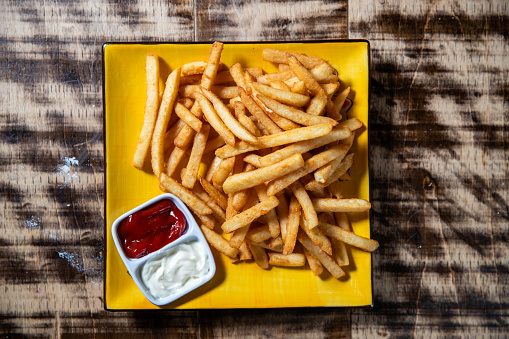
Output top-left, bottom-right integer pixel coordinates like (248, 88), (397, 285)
(141, 241), (210, 298)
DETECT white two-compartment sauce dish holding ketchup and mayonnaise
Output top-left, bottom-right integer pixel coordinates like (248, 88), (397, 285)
(111, 193), (216, 306)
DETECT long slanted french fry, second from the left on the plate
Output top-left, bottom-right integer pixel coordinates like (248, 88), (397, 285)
(151, 68), (182, 177)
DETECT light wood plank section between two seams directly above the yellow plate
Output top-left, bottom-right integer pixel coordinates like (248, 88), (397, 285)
(195, 0), (348, 41)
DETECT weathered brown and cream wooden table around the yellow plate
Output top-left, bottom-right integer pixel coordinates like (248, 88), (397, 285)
(0, 0), (509, 338)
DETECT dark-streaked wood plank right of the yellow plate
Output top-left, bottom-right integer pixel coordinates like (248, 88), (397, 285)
(349, 0), (509, 337)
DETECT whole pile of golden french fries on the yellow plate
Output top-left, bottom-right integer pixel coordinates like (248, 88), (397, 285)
(133, 42), (378, 278)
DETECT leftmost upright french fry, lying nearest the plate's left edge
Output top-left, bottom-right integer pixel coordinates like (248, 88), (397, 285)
(133, 54), (159, 169)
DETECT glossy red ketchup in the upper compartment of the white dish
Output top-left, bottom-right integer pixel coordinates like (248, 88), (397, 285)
(117, 199), (187, 259)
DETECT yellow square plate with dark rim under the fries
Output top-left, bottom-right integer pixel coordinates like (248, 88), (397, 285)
(103, 40), (372, 310)
